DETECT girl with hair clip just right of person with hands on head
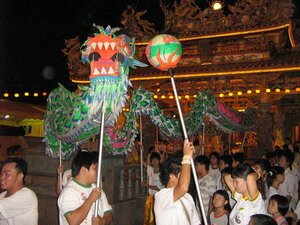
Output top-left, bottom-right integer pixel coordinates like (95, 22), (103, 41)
(267, 166), (284, 204)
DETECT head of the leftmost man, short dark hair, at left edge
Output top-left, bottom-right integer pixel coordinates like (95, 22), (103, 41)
(0, 157), (27, 194)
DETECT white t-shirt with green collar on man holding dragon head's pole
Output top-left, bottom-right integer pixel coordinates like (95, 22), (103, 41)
(57, 179), (112, 225)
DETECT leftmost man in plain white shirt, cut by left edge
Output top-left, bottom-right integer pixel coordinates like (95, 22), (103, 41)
(0, 157), (38, 225)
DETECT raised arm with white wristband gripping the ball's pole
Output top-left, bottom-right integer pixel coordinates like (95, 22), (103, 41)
(173, 140), (195, 202)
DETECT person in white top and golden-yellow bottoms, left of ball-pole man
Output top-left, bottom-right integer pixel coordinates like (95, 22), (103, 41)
(141, 152), (163, 225)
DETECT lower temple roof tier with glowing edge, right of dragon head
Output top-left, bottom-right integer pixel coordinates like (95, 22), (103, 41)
(130, 51), (300, 81)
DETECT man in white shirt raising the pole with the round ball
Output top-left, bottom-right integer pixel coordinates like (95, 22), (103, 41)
(154, 141), (200, 225)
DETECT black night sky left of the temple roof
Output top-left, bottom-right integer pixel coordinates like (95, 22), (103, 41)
(0, 0), (299, 104)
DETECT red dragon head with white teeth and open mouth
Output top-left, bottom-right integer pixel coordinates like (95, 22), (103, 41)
(81, 24), (147, 83)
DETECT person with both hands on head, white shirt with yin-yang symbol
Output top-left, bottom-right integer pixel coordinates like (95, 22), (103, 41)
(225, 164), (266, 225)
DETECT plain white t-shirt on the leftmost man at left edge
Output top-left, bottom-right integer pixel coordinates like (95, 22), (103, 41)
(0, 187), (38, 225)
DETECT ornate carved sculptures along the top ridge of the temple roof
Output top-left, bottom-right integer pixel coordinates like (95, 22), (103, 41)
(121, 0), (295, 39)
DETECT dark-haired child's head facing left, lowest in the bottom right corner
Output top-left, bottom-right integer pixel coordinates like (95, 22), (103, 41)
(268, 195), (289, 225)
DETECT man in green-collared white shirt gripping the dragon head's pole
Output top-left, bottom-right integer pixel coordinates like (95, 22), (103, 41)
(58, 152), (113, 225)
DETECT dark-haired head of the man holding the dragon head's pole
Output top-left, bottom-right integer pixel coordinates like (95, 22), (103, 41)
(71, 151), (98, 185)
